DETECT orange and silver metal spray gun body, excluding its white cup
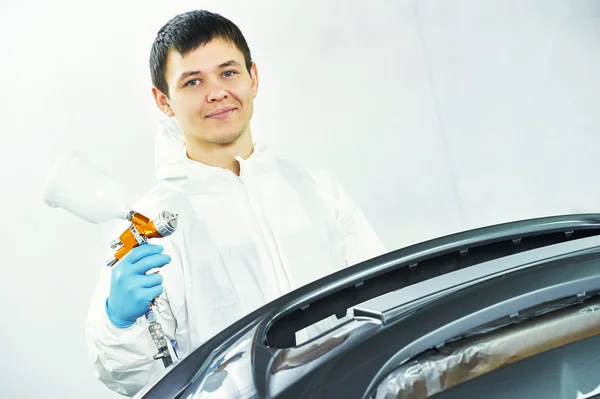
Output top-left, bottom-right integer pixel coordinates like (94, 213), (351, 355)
(106, 211), (177, 367)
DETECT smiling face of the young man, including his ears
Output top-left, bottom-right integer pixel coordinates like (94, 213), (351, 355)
(153, 39), (258, 145)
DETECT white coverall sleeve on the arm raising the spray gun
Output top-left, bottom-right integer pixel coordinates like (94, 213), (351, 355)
(85, 223), (183, 396)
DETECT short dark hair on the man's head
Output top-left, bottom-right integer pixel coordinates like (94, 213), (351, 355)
(150, 10), (252, 96)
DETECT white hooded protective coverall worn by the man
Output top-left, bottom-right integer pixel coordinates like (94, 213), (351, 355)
(85, 119), (386, 396)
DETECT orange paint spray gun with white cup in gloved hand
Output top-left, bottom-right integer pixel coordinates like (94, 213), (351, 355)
(44, 153), (177, 368)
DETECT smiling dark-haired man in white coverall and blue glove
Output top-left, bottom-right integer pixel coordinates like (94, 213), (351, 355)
(86, 11), (385, 395)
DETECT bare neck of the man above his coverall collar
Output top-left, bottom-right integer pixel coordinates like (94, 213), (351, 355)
(184, 127), (254, 176)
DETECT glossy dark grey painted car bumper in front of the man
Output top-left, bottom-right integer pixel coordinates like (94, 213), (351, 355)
(138, 214), (600, 399)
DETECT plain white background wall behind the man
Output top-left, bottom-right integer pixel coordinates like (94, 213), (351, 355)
(0, 0), (600, 399)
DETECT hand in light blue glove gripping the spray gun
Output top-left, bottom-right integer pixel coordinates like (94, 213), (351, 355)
(106, 244), (171, 328)
